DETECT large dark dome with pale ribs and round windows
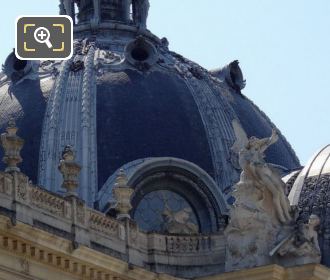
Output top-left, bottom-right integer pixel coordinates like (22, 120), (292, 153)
(0, 0), (300, 231)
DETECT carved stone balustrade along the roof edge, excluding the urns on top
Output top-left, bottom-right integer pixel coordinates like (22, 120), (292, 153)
(0, 172), (225, 275)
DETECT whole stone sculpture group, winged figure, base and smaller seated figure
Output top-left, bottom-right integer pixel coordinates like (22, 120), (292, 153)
(225, 121), (321, 271)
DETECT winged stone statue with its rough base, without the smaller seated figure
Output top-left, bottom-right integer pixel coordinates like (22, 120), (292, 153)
(225, 121), (293, 271)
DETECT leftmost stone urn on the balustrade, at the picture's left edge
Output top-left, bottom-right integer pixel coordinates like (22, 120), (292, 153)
(1, 120), (24, 172)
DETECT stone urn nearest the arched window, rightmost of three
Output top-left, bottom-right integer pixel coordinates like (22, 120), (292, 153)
(112, 169), (134, 220)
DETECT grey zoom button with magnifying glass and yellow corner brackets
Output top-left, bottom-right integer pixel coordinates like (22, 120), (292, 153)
(15, 16), (73, 60)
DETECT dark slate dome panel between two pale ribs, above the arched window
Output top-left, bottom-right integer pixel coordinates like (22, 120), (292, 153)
(97, 69), (214, 185)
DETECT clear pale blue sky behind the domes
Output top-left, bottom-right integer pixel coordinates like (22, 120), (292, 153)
(0, 0), (330, 164)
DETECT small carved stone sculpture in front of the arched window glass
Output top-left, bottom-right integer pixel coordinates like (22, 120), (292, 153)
(162, 206), (198, 234)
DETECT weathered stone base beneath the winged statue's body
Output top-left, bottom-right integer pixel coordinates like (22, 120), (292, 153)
(225, 174), (288, 271)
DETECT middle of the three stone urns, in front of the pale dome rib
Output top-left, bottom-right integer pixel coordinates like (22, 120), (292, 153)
(58, 145), (81, 196)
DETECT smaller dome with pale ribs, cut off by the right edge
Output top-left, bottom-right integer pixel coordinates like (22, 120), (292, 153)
(289, 145), (330, 266)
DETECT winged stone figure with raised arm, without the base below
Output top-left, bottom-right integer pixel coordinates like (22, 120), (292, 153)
(232, 120), (292, 224)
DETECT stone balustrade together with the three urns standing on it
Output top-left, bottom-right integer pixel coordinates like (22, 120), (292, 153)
(0, 123), (225, 279)
